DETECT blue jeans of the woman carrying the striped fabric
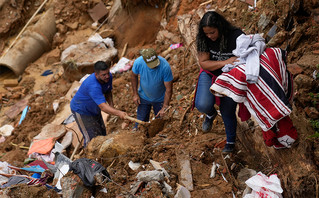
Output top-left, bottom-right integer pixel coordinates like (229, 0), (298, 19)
(195, 72), (237, 143)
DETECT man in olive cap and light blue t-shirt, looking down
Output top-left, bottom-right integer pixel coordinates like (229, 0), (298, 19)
(131, 48), (173, 129)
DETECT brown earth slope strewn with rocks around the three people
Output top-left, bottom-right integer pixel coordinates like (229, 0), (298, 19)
(0, 0), (319, 197)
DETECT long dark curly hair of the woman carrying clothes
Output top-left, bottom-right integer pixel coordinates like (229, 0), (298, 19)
(196, 11), (236, 52)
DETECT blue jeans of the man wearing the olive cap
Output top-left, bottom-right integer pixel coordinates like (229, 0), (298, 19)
(134, 97), (163, 128)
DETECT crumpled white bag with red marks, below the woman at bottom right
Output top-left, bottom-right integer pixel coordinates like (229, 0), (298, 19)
(244, 172), (283, 198)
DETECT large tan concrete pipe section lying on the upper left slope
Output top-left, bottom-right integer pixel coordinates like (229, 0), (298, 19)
(0, 8), (56, 76)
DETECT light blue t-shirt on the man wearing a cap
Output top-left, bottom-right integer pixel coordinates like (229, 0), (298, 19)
(132, 56), (173, 102)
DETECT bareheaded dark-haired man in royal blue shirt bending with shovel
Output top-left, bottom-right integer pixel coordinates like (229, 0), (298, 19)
(70, 61), (127, 146)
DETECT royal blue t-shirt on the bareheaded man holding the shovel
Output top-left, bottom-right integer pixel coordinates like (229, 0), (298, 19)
(70, 73), (113, 116)
